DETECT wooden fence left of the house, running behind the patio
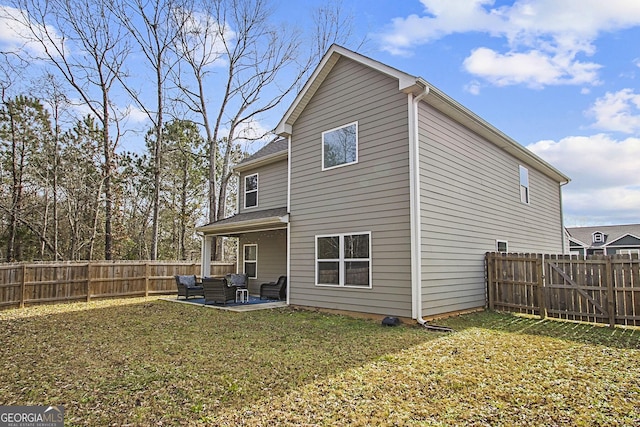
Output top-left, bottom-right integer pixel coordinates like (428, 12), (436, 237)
(0, 261), (236, 308)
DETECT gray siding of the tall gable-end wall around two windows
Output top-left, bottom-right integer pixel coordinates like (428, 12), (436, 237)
(289, 58), (411, 316)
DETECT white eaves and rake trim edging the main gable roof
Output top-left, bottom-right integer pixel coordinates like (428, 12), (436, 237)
(276, 44), (569, 183)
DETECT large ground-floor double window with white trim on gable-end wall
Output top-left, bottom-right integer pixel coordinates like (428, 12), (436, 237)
(316, 232), (371, 288)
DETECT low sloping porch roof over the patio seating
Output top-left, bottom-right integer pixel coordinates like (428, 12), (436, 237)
(196, 207), (289, 235)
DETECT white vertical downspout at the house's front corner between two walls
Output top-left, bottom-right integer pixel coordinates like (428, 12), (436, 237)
(408, 86), (429, 325)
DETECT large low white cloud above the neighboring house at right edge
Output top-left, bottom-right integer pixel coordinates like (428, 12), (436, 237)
(527, 134), (640, 225)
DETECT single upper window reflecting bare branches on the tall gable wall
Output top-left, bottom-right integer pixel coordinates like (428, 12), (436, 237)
(322, 122), (358, 170)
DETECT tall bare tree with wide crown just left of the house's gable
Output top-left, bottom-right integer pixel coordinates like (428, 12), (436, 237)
(172, 0), (358, 259)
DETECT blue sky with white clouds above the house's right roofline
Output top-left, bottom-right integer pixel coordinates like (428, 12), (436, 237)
(0, 0), (640, 226)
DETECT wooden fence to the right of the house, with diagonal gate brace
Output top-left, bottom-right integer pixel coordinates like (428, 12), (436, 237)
(485, 252), (640, 326)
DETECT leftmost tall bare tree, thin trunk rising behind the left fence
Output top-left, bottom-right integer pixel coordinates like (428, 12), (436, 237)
(12, 0), (130, 259)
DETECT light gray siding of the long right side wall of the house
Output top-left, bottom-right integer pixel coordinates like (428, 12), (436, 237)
(419, 102), (563, 316)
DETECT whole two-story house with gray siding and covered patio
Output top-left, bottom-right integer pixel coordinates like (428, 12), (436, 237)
(199, 45), (568, 322)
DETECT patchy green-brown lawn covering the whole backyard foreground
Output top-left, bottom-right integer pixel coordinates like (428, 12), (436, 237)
(0, 298), (640, 426)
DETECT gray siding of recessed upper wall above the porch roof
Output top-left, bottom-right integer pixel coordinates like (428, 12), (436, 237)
(239, 159), (287, 213)
